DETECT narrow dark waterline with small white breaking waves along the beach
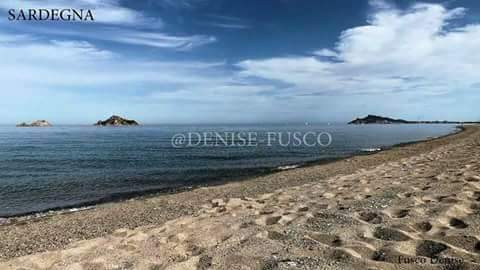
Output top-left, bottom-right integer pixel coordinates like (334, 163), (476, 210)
(0, 125), (466, 219)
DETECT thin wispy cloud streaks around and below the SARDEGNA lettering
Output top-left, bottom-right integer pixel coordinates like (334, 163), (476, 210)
(0, 0), (216, 51)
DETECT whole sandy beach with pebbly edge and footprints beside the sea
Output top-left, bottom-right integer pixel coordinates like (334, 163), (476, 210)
(0, 126), (480, 269)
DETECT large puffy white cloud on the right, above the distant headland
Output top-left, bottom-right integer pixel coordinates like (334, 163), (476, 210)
(238, 1), (480, 96)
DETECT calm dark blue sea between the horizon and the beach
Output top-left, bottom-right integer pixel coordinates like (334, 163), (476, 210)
(0, 124), (455, 217)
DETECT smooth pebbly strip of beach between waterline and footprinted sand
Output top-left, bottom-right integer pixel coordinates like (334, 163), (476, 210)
(0, 126), (472, 261)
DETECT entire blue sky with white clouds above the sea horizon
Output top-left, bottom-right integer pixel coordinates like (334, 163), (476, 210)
(0, 0), (480, 124)
